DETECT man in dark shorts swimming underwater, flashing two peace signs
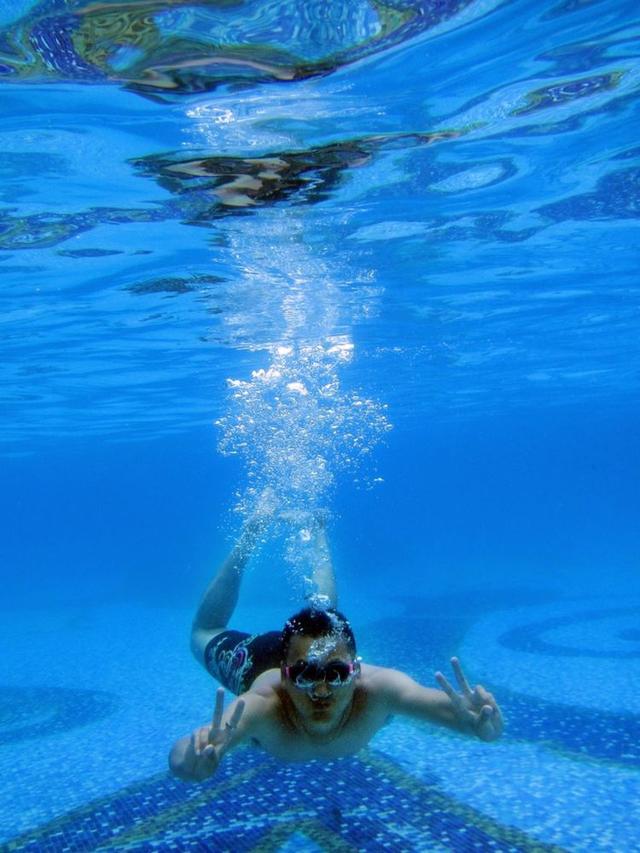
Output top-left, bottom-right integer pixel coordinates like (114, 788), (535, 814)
(169, 509), (503, 782)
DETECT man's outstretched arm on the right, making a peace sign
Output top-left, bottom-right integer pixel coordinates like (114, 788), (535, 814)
(385, 658), (504, 741)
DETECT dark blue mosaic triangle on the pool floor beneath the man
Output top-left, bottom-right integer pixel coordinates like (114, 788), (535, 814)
(6, 750), (562, 853)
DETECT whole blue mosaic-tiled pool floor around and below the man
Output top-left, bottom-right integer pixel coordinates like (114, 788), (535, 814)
(0, 592), (640, 853)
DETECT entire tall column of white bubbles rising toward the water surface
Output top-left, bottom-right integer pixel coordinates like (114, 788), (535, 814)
(210, 205), (391, 579)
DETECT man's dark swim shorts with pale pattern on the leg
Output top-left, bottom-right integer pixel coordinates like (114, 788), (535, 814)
(204, 631), (282, 695)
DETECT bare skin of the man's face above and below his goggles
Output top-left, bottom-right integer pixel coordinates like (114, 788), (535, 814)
(282, 635), (356, 734)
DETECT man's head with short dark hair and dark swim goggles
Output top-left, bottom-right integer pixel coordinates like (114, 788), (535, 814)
(281, 607), (360, 733)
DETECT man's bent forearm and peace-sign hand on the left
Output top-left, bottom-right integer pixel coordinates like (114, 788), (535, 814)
(169, 687), (268, 782)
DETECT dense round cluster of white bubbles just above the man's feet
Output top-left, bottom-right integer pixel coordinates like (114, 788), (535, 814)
(216, 336), (391, 515)
